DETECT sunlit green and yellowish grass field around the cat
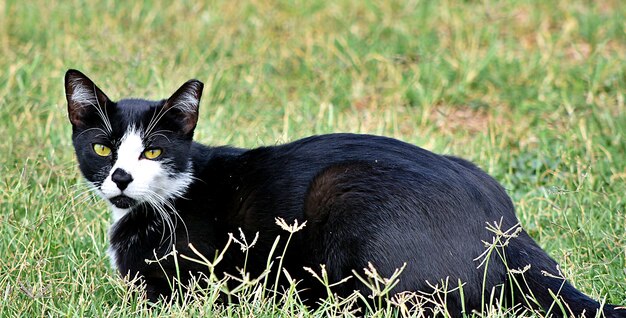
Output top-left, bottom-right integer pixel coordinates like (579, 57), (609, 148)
(0, 0), (626, 317)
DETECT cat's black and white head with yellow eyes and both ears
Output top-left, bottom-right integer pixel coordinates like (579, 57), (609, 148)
(65, 70), (203, 219)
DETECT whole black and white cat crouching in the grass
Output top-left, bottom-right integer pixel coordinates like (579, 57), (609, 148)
(65, 70), (626, 317)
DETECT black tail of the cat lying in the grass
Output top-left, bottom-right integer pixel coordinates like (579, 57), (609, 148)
(506, 231), (626, 318)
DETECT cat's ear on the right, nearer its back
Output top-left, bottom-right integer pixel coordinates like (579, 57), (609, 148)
(163, 80), (204, 135)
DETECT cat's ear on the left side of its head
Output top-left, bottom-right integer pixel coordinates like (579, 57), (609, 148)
(65, 70), (109, 127)
